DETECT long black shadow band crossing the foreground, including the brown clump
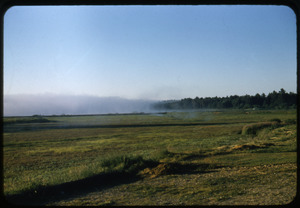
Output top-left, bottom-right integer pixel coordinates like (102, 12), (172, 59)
(6, 162), (218, 206)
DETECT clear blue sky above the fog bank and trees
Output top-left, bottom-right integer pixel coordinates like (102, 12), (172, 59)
(3, 5), (297, 113)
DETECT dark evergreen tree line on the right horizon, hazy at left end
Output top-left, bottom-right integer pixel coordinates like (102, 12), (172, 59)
(153, 88), (297, 110)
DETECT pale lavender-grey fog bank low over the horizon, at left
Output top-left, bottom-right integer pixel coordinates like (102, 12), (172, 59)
(3, 94), (157, 116)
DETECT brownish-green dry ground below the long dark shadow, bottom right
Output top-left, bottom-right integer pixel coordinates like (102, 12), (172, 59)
(49, 164), (297, 205)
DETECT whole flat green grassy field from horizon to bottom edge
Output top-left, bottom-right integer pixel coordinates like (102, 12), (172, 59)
(3, 110), (297, 205)
